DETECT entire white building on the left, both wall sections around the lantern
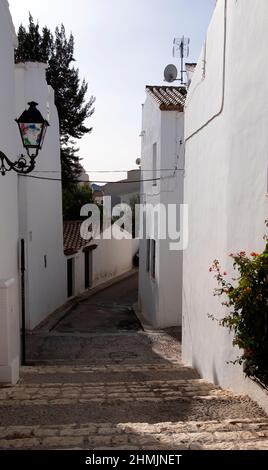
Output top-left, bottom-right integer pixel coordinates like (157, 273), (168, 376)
(0, 0), (67, 383)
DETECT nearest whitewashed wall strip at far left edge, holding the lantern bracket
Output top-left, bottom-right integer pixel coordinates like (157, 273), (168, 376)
(0, 0), (21, 383)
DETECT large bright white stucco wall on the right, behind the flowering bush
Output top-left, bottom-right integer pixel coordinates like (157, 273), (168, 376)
(182, 0), (268, 392)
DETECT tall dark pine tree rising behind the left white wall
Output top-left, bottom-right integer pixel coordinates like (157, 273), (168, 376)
(15, 15), (95, 183)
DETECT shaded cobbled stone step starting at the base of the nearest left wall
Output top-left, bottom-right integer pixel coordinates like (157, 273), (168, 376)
(0, 379), (227, 406)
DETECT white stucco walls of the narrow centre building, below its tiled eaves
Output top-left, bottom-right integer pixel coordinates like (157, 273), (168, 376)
(139, 97), (184, 328)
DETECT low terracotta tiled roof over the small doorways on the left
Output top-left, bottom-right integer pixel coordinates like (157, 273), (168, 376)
(63, 220), (91, 256)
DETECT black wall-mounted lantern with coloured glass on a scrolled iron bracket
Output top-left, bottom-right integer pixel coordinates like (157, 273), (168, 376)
(0, 101), (49, 176)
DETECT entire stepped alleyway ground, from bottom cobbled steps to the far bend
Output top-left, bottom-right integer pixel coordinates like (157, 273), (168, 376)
(0, 275), (268, 450)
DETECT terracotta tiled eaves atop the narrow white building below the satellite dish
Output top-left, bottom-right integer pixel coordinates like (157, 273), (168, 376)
(146, 85), (187, 112)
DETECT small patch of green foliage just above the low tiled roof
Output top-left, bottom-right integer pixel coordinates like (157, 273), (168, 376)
(62, 184), (93, 220)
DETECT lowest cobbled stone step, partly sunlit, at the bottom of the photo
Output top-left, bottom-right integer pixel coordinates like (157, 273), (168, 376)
(0, 418), (268, 450)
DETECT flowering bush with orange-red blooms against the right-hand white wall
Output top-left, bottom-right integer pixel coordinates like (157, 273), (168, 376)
(209, 221), (268, 382)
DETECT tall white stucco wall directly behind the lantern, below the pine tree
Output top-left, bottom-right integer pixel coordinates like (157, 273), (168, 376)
(16, 63), (67, 329)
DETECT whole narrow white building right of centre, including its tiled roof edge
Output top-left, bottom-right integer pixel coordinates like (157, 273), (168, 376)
(139, 86), (186, 328)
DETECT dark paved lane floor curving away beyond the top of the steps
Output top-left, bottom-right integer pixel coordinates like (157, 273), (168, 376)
(27, 274), (145, 364)
